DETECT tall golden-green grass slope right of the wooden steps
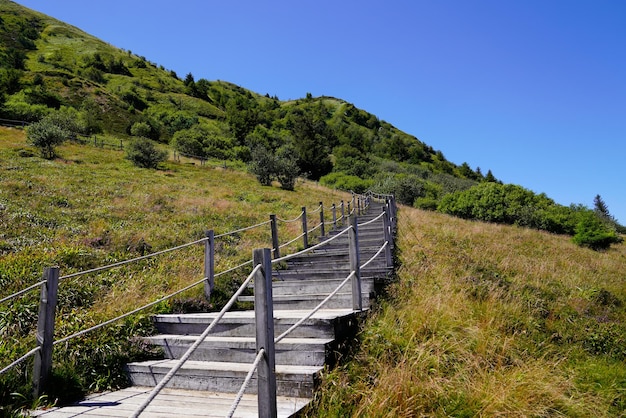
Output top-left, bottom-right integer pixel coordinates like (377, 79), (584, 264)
(309, 207), (626, 417)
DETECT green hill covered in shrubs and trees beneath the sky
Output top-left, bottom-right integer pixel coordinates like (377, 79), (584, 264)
(0, 0), (491, 204)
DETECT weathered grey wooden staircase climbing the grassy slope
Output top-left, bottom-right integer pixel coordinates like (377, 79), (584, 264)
(34, 202), (390, 417)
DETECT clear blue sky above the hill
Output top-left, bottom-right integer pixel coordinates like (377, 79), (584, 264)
(18, 0), (626, 224)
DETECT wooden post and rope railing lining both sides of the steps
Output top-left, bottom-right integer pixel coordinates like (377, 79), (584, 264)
(0, 192), (396, 410)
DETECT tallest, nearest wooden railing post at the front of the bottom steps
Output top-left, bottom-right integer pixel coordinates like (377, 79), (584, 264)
(252, 248), (277, 418)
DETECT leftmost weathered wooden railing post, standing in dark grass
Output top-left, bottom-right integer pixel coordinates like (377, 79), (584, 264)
(33, 267), (59, 399)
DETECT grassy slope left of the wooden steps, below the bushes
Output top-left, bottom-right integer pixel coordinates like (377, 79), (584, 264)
(0, 128), (350, 416)
